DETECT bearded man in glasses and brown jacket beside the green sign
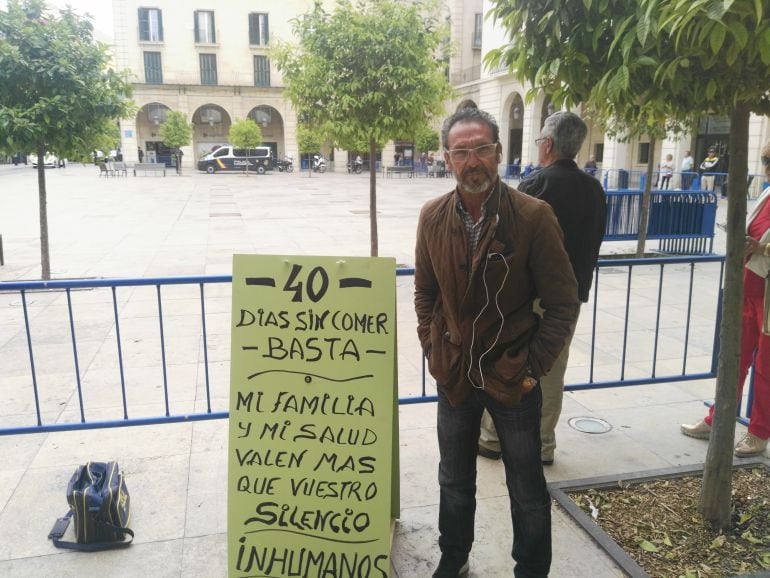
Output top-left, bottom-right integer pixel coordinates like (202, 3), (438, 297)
(415, 101), (579, 578)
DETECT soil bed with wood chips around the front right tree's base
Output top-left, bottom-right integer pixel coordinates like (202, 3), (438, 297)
(549, 457), (770, 578)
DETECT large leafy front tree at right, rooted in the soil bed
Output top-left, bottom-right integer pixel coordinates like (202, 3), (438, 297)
(488, 0), (770, 528)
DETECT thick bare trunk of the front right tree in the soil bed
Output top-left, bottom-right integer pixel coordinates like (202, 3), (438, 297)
(699, 104), (749, 529)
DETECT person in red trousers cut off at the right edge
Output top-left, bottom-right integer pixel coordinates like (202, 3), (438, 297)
(681, 142), (770, 457)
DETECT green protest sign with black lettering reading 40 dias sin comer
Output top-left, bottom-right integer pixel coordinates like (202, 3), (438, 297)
(227, 255), (396, 578)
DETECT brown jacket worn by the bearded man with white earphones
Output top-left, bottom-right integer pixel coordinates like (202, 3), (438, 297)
(414, 180), (580, 405)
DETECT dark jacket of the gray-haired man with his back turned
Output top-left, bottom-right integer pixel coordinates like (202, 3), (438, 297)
(519, 159), (607, 303)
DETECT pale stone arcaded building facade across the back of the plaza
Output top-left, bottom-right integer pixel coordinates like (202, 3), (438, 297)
(112, 0), (770, 180)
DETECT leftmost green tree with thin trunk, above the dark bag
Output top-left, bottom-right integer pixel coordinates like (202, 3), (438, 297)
(0, 0), (132, 279)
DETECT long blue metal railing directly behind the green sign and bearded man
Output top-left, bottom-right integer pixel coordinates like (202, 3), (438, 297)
(0, 256), (752, 436)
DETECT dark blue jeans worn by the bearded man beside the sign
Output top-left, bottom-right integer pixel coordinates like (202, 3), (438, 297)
(437, 384), (551, 578)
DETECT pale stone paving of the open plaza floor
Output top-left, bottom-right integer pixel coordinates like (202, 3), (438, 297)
(0, 165), (745, 578)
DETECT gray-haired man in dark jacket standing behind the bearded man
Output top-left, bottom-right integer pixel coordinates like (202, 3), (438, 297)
(479, 111), (607, 465)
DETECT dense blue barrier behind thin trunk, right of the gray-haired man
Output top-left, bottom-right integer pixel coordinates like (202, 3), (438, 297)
(604, 190), (717, 254)
